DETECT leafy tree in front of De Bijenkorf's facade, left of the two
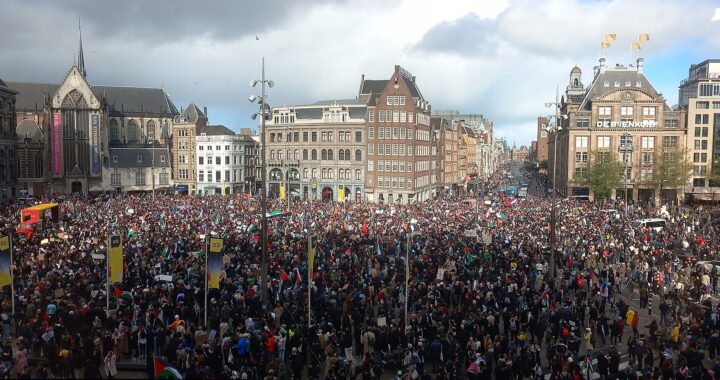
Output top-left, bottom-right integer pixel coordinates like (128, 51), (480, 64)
(577, 152), (624, 199)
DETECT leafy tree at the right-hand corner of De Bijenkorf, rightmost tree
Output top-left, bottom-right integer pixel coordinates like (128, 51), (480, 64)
(653, 144), (693, 203)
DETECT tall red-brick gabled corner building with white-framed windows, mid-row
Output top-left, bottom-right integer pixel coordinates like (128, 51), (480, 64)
(358, 65), (438, 203)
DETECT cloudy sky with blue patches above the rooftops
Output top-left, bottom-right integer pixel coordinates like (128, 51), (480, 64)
(0, 0), (720, 145)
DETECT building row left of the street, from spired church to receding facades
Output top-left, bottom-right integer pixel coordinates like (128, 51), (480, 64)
(0, 33), (509, 203)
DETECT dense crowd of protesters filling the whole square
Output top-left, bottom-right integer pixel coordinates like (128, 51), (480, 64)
(0, 161), (720, 379)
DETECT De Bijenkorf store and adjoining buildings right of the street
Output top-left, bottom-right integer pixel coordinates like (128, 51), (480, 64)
(532, 58), (720, 203)
